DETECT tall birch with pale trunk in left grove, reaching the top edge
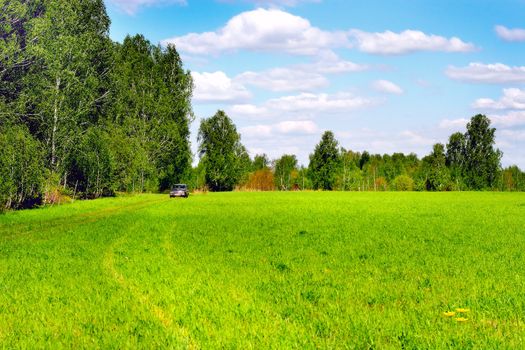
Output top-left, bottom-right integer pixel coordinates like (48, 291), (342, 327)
(19, 0), (110, 175)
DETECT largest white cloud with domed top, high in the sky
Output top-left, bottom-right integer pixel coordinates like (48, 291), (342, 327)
(162, 9), (350, 55)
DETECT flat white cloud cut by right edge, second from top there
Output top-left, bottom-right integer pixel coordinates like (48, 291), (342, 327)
(445, 62), (525, 84)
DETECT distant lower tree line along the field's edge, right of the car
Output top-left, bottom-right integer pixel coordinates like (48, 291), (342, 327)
(192, 111), (525, 191)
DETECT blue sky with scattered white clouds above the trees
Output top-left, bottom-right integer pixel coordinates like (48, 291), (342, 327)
(106, 0), (525, 169)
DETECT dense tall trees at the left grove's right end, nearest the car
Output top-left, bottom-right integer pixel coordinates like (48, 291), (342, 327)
(109, 35), (193, 191)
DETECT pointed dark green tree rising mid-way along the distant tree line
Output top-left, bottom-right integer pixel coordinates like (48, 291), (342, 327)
(308, 131), (340, 190)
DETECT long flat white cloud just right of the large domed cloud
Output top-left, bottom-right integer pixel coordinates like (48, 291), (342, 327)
(350, 29), (476, 55)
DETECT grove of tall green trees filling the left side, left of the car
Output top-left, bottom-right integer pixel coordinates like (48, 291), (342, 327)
(0, 0), (194, 209)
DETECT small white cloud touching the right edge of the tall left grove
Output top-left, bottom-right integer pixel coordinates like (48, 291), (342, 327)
(191, 71), (252, 102)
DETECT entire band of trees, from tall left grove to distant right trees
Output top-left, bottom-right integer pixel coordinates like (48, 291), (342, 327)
(0, 0), (525, 210)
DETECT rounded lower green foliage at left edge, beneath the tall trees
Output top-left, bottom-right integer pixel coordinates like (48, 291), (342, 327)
(0, 126), (45, 211)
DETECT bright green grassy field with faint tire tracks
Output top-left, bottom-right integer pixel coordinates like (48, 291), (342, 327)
(0, 192), (525, 349)
